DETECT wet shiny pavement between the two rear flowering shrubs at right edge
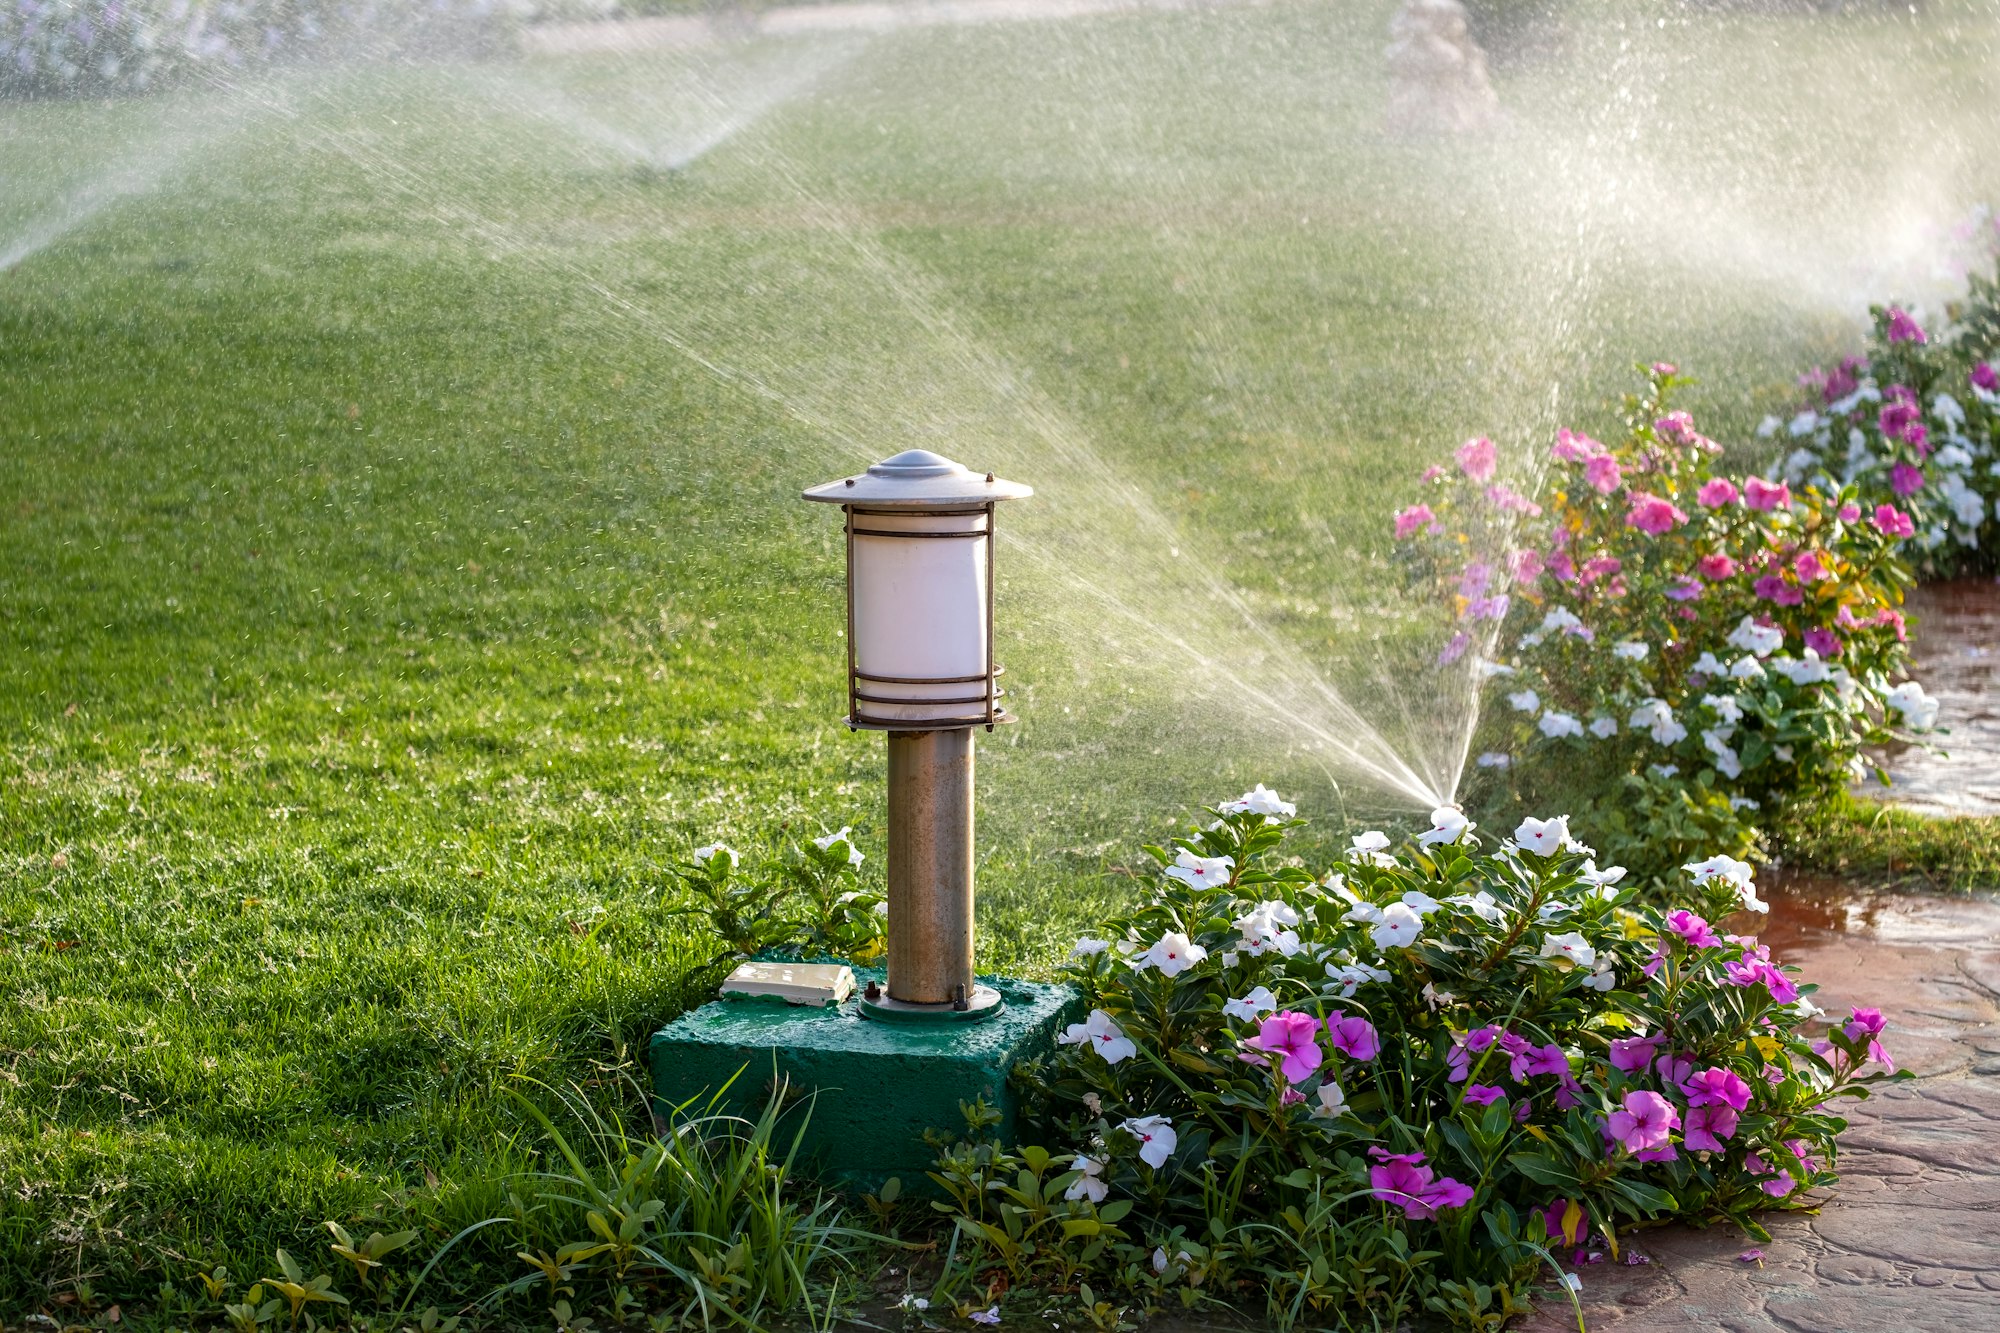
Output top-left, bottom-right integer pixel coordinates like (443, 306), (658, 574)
(1858, 578), (2000, 816)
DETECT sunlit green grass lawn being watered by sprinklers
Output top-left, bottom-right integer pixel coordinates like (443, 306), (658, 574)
(0, 2), (2000, 1313)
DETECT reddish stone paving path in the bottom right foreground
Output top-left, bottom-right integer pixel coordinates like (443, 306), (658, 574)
(1524, 883), (2000, 1333)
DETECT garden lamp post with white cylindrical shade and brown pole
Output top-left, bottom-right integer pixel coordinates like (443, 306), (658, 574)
(806, 448), (1034, 1021)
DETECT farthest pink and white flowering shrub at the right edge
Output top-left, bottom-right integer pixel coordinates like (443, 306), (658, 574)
(1760, 224), (2000, 574)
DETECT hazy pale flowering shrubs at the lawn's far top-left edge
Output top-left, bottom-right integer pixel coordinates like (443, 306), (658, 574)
(0, 0), (530, 98)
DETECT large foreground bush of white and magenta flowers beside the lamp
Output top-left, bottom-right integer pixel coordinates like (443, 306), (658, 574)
(936, 789), (1894, 1329)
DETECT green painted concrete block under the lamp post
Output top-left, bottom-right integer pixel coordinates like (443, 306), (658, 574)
(648, 973), (1082, 1193)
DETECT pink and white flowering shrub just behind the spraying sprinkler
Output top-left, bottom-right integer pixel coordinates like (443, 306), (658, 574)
(1394, 364), (1936, 881)
